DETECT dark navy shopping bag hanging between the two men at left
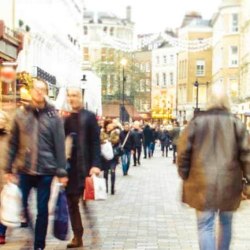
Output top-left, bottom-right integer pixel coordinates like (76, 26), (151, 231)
(53, 188), (69, 240)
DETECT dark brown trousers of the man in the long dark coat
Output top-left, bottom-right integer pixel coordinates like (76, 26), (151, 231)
(67, 194), (83, 238)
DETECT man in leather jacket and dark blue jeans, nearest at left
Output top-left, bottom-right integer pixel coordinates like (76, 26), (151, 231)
(6, 79), (67, 250)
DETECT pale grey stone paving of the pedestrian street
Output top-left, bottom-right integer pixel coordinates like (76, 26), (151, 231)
(0, 147), (250, 250)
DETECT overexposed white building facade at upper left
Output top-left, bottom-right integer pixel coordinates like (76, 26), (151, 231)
(16, 0), (83, 98)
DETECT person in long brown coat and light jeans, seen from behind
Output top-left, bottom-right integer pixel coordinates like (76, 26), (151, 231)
(178, 89), (250, 250)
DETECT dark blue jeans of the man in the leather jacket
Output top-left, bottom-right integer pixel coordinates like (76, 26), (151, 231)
(19, 174), (53, 249)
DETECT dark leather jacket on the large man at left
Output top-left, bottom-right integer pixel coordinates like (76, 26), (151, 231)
(6, 104), (67, 177)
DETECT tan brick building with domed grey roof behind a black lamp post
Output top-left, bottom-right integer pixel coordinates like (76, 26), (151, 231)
(176, 12), (212, 121)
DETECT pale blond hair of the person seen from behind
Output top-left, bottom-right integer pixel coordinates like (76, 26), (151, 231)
(207, 84), (231, 111)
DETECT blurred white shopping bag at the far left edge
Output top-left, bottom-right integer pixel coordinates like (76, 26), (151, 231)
(0, 182), (23, 227)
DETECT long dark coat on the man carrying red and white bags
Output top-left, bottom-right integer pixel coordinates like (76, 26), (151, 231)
(65, 109), (101, 194)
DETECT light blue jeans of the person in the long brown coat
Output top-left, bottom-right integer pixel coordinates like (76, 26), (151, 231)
(196, 211), (233, 250)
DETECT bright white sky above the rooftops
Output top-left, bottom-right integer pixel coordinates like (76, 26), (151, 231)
(84, 0), (221, 34)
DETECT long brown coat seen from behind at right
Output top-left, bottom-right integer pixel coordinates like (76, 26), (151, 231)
(177, 109), (250, 211)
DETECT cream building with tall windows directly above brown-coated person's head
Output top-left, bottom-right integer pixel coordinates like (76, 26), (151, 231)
(212, 0), (241, 104)
